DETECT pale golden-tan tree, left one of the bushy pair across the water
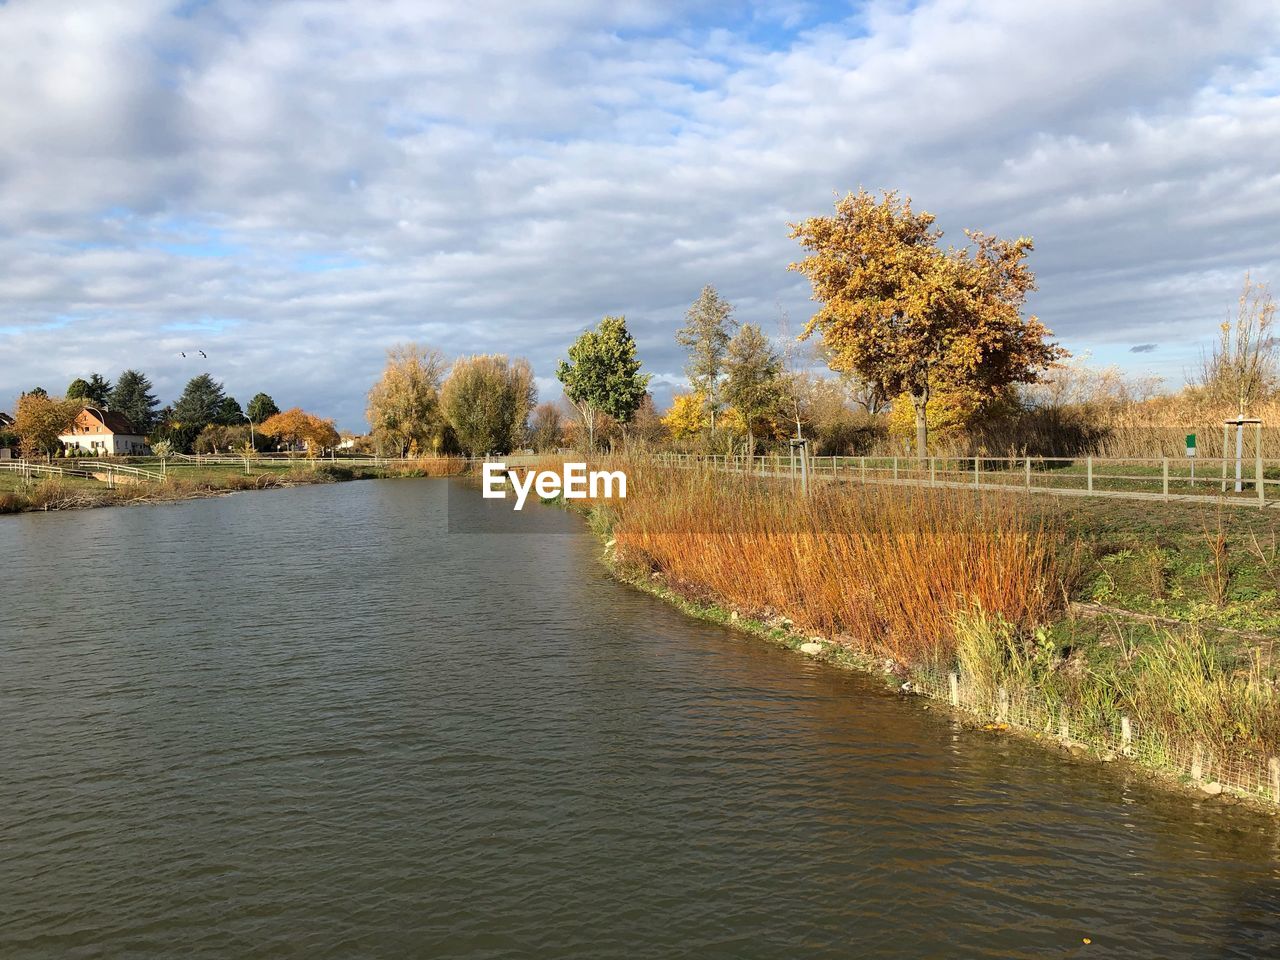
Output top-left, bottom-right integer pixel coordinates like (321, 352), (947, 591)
(365, 343), (445, 457)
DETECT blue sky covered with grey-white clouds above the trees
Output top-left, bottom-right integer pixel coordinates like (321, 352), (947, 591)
(0, 0), (1280, 430)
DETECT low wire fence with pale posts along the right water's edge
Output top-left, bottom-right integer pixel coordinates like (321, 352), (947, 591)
(911, 672), (1280, 804)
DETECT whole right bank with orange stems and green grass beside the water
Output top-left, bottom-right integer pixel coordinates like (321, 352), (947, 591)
(573, 465), (1280, 795)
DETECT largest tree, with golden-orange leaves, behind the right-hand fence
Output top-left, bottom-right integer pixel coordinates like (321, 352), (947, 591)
(791, 191), (1065, 457)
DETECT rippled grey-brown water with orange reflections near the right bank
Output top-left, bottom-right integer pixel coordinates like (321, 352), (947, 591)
(0, 480), (1280, 957)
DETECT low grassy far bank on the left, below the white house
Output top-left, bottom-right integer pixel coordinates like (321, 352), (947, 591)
(0, 458), (466, 513)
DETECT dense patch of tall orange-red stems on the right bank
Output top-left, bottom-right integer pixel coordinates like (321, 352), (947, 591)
(613, 465), (1060, 663)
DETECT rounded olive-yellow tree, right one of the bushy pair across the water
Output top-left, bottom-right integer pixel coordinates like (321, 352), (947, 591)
(440, 355), (538, 457)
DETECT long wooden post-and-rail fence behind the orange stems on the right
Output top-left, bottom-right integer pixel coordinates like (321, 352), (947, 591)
(655, 453), (1280, 507)
